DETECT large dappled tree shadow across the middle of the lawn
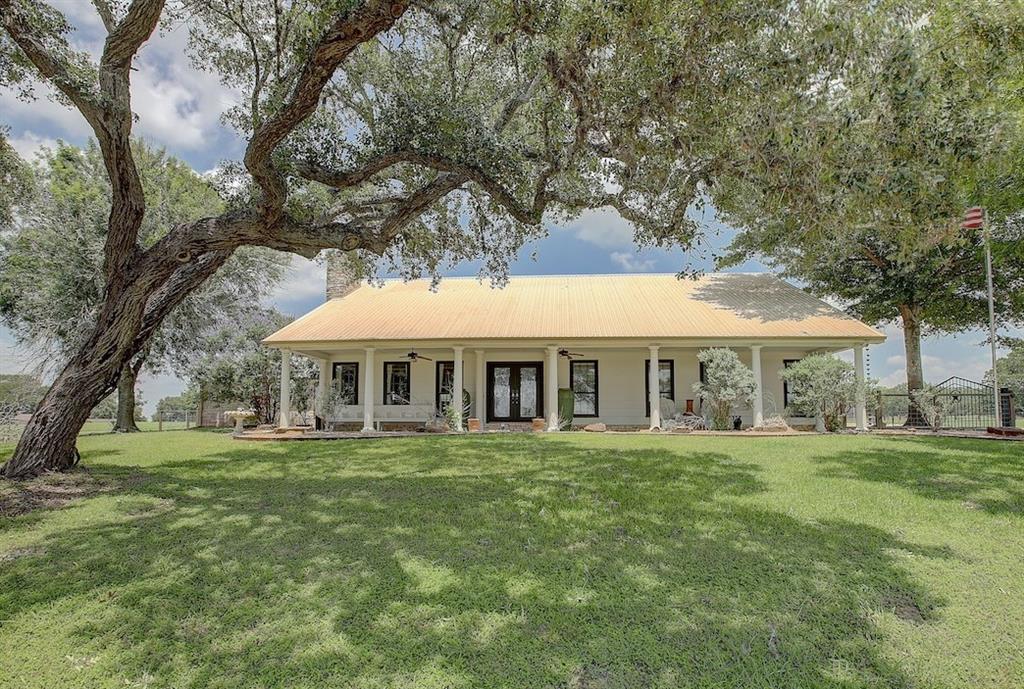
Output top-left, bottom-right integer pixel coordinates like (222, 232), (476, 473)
(0, 437), (944, 687)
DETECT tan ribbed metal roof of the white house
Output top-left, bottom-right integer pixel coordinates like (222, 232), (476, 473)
(265, 273), (885, 345)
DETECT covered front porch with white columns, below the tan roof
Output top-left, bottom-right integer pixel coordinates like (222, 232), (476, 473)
(272, 340), (867, 434)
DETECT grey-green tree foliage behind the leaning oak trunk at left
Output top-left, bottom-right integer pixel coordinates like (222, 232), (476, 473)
(0, 140), (284, 430)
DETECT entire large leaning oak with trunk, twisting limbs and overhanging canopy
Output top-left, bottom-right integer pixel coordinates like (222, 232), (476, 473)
(0, 0), (905, 477)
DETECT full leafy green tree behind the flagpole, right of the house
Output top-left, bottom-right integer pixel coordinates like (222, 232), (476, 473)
(715, 3), (1024, 390)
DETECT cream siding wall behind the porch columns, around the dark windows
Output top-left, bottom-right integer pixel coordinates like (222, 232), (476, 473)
(323, 345), (827, 426)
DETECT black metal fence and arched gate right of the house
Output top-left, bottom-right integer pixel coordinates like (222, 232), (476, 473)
(874, 376), (1016, 429)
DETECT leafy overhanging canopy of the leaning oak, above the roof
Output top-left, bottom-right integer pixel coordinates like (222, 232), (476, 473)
(178, 0), (872, 279)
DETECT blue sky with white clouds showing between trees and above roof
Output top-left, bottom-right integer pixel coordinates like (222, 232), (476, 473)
(0, 1), (1007, 413)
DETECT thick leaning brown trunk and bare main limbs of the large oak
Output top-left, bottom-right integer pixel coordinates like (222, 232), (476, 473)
(0, 0), (407, 478)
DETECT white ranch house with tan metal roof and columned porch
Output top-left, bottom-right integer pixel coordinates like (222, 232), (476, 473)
(264, 268), (885, 431)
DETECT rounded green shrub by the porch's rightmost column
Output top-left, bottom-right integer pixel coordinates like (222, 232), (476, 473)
(779, 354), (866, 432)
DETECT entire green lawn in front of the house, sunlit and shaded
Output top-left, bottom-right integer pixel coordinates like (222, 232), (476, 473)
(0, 431), (1024, 689)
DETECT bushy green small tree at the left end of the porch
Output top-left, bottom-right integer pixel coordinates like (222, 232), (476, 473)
(189, 309), (318, 424)
